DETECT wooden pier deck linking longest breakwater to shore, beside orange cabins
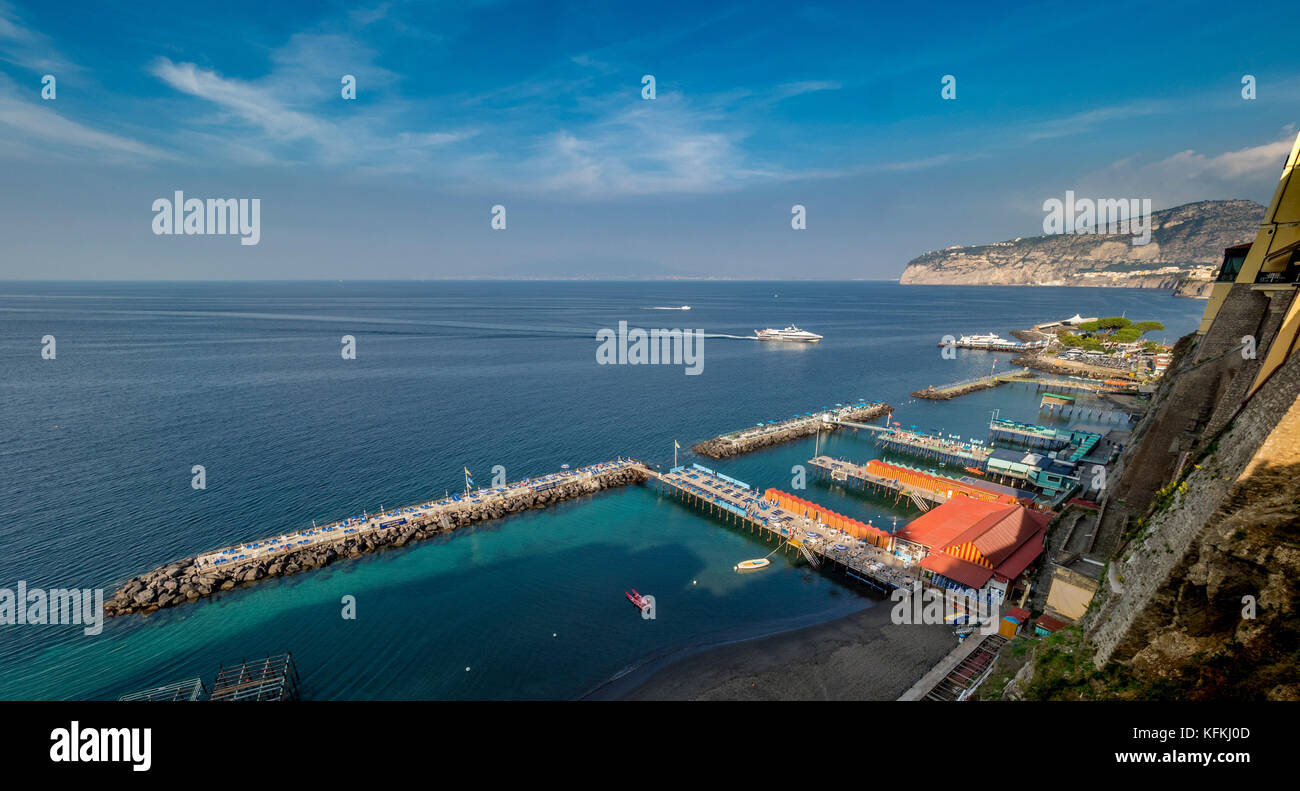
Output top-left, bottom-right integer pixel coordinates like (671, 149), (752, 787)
(647, 466), (920, 593)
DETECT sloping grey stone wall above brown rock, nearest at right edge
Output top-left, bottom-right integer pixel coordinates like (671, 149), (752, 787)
(1086, 346), (1300, 677)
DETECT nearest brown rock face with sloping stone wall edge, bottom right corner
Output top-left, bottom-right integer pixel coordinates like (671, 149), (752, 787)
(1086, 346), (1300, 700)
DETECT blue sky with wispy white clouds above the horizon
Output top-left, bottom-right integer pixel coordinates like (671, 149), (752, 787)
(0, 0), (1300, 280)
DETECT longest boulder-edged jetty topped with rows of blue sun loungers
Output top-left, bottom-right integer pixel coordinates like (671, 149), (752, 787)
(104, 459), (649, 617)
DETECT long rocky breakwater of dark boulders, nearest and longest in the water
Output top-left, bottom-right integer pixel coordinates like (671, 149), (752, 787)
(104, 464), (647, 617)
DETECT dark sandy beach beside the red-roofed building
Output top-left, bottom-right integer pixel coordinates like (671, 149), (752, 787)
(598, 601), (957, 700)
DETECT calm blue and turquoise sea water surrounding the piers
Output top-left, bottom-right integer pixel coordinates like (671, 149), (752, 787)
(0, 282), (1204, 699)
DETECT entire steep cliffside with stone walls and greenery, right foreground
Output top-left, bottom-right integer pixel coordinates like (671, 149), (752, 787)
(1008, 312), (1300, 700)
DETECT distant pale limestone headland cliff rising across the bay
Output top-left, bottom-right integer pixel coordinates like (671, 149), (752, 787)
(900, 200), (1264, 288)
